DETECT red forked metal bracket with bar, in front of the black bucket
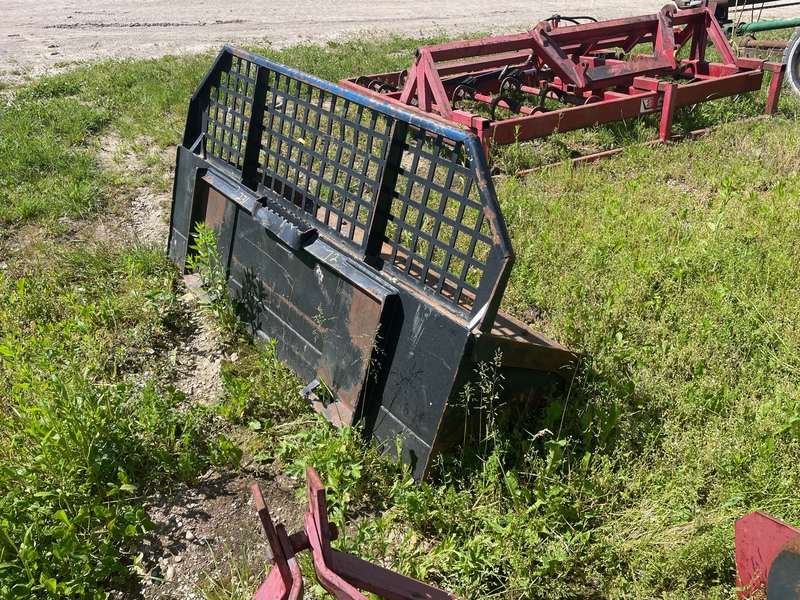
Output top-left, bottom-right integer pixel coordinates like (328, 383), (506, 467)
(253, 467), (458, 600)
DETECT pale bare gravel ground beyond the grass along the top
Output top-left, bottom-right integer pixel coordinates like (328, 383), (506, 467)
(0, 0), (796, 80)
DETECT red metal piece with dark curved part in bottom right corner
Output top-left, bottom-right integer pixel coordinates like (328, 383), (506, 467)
(735, 511), (800, 600)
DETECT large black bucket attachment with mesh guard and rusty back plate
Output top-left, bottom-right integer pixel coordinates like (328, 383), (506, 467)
(169, 47), (575, 478)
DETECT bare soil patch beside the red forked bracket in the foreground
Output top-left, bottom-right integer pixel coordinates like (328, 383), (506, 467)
(129, 470), (305, 599)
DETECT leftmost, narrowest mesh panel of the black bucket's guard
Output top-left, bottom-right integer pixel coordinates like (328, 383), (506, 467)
(203, 56), (258, 171)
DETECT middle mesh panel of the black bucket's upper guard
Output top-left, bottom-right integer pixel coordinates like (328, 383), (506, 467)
(259, 71), (393, 246)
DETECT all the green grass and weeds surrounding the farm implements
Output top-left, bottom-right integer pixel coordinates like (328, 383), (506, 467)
(0, 32), (800, 598)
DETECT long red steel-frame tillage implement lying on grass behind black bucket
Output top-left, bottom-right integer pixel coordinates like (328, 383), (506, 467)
(340, 5), (785, 153)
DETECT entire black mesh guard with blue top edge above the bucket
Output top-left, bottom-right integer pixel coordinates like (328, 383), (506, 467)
(191, 51), (510, 324)
